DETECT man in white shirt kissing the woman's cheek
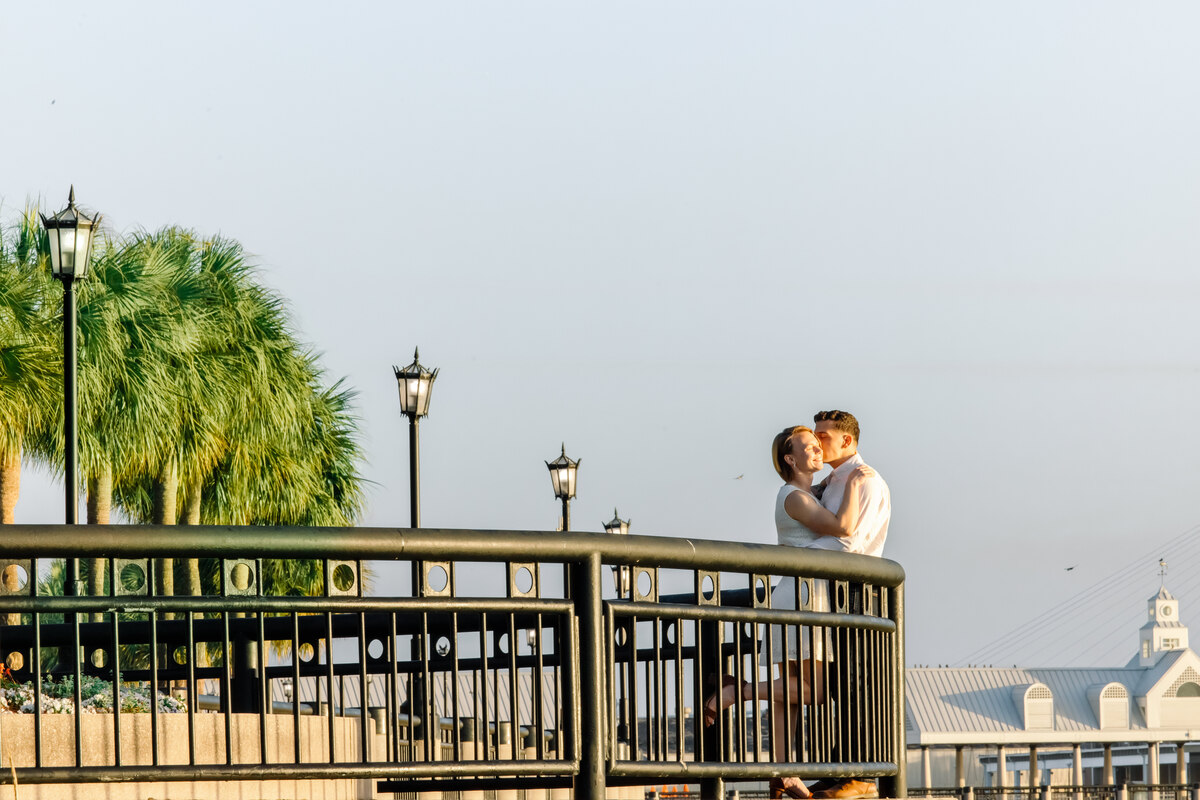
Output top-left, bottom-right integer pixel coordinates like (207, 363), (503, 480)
(811, 410), (892, 800)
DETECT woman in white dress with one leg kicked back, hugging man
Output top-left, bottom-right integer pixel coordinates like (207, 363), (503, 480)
(704, 425), (875, 798)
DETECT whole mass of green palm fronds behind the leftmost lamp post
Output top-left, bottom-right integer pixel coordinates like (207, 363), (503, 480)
(0, 209), (364, 594)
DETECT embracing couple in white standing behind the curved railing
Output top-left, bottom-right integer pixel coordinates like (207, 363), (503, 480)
(704, 410), (892, 799)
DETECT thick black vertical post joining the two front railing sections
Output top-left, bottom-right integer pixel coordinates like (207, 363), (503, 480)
(570, 553), (612, 800)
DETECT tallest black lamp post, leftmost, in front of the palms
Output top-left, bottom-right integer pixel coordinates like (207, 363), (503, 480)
(40, 186), (101, 595)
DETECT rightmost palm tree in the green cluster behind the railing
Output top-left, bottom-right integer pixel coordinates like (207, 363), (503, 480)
(112, 230), (361, 594)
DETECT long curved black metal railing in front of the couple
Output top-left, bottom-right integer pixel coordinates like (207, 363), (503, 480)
(0, 525), (905, 798)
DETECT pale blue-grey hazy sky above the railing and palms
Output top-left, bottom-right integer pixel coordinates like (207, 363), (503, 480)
(0, 0), (1200, 666)
